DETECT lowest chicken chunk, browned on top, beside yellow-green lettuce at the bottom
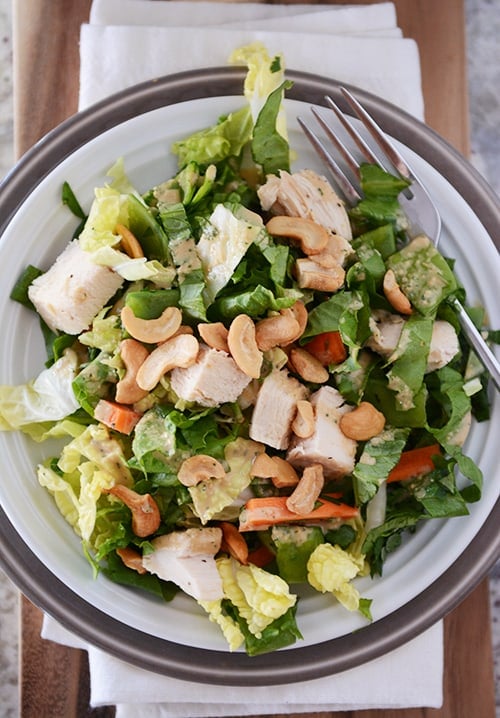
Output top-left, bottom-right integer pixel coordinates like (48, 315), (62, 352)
(142, 527), (224, 601)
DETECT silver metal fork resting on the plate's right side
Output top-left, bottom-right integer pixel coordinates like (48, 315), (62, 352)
(297, 87), (500, 389)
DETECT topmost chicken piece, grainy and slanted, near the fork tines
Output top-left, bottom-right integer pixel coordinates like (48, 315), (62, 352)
(258, 170), (352, 240)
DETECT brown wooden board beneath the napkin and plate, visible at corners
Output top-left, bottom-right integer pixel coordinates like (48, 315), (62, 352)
(13, 0), (495, 718)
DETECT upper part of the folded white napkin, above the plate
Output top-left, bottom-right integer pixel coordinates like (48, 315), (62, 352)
(80, 0), (424, 119)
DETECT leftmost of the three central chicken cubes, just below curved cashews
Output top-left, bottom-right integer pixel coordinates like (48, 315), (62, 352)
(170, 344), (251, 407)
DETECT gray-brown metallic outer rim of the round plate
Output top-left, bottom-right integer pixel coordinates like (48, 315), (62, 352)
(0, 67), (500, 686)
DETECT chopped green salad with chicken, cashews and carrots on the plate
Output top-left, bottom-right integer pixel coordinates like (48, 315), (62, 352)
(0, 44), (494, 655)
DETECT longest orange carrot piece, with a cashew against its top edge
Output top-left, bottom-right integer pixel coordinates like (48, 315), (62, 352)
(240, 496), (359, 531)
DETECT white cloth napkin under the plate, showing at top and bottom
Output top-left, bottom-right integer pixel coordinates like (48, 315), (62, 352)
(42, 0), (443, 718)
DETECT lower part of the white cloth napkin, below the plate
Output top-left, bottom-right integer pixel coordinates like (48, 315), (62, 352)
(42, 616), (443, 718)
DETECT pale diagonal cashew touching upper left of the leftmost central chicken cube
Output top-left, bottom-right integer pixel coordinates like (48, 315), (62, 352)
(136, 334), (200, 391)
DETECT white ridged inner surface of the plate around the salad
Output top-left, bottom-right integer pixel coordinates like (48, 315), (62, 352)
(0, 69), (500, 682)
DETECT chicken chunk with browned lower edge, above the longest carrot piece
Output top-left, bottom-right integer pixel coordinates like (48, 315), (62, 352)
(287, 386), (357, 479)
